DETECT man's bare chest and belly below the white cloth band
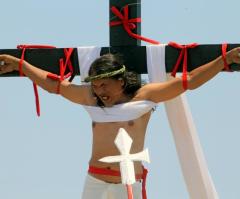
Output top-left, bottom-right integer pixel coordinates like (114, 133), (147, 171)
(84, 84), (152, 183)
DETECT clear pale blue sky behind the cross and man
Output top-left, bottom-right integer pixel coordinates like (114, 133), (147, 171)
(0, 0), (240, 199)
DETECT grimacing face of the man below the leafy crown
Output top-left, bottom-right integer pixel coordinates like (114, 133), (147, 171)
(92, 78), (124, 106)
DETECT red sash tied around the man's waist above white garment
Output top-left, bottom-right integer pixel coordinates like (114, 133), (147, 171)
(88, 166), (148, 199)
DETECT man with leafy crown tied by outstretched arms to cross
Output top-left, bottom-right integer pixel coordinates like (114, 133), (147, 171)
(0, 48), (240, 199)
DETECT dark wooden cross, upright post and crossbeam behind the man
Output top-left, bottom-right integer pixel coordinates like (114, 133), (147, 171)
(0, 0), (240, 77)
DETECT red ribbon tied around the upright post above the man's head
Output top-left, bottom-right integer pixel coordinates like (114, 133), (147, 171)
(110, 5), (160, 44)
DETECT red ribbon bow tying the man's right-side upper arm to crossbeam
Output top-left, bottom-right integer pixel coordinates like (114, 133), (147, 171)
(168, 42), (198, 90)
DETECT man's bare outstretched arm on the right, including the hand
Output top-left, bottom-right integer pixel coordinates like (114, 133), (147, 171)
(137, 48), (240, 103)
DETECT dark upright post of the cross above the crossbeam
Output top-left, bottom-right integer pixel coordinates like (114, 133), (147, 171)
(109, 0), (141, 46)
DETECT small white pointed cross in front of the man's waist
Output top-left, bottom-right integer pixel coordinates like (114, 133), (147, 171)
(99, 128), (150, 185)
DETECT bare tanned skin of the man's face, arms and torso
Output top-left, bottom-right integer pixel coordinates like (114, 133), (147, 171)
(0, 48), (240, 183)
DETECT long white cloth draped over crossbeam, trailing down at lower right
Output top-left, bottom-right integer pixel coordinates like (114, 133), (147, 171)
(78, 45), (218, 199)
